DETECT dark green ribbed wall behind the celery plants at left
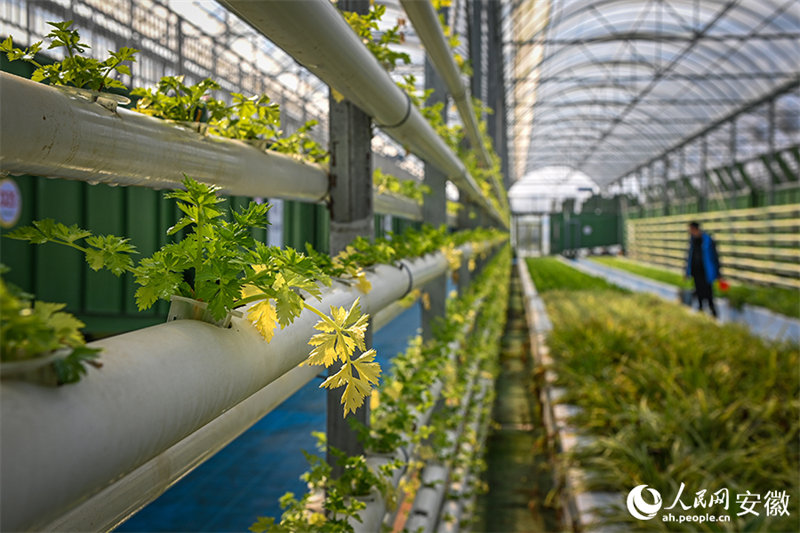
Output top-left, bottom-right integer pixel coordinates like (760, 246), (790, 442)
(0, 172), (278, 337)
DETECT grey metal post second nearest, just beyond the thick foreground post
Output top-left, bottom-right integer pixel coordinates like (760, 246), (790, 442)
(422, 57), (447, 341)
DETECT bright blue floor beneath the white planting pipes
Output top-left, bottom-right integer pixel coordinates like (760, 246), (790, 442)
(116, 304), (421, 532)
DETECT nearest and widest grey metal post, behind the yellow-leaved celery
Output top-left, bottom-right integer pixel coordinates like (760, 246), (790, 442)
(327, 0), (375, 470)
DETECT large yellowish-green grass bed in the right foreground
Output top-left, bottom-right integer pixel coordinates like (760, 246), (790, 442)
(543, 291), (800, 532)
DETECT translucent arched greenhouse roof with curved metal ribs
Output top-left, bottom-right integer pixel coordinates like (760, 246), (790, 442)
(508, 0), (800, 186)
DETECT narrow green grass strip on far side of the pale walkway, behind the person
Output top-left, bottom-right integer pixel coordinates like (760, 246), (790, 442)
(592, 257), (800, 318)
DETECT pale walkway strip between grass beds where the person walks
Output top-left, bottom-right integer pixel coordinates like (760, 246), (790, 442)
(562, 258), (800, 342)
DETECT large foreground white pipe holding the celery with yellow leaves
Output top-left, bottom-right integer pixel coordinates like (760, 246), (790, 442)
(0, 245), (496, 531)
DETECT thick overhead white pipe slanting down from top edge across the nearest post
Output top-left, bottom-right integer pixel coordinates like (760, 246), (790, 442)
(219, 0), (507, 226)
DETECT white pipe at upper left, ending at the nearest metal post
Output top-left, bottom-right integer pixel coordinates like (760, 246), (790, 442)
(0, 72), (328, 202)
